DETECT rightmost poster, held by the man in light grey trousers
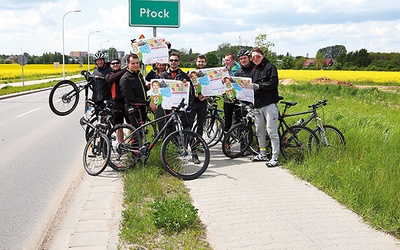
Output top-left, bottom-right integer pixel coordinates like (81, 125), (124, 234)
(223, 76), (254, 104)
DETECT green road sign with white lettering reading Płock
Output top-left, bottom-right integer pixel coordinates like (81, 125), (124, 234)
(129, 0), (180, 28)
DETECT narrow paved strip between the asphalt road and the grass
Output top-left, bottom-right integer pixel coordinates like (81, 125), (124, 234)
(50, 167), (123, 250)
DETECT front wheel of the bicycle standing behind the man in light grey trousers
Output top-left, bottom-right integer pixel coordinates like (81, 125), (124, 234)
(222, 123), (255, 158)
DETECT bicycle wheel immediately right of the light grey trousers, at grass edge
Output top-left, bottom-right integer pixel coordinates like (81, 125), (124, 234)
(281, 125), (319, 162)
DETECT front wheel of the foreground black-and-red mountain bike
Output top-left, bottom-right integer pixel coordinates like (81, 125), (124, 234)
(161, 130), (210, 180)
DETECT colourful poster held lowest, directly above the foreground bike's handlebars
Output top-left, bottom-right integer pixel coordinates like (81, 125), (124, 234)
(147, 79), (189, 109)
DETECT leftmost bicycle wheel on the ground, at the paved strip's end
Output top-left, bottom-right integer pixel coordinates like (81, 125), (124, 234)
(83, 134), (111, 176)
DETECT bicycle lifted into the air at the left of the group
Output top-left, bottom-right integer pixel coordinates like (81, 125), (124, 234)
(49, 70), (97, 116)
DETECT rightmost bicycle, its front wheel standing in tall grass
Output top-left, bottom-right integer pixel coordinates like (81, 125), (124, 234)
(284, 99), (346, 150)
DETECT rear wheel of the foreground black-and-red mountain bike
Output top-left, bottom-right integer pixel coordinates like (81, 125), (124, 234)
(108, 123), (142, 171)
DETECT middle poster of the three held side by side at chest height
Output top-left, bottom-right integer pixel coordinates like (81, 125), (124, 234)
(188, 67), (229, 96)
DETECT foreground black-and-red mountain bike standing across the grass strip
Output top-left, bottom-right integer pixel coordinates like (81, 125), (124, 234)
(110, 99), (210, 180)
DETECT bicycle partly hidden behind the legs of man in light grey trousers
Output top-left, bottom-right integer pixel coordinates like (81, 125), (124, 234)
(222, 97), (319, 161)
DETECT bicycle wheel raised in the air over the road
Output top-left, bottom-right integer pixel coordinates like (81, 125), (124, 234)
(49, 80), (79, 116)
